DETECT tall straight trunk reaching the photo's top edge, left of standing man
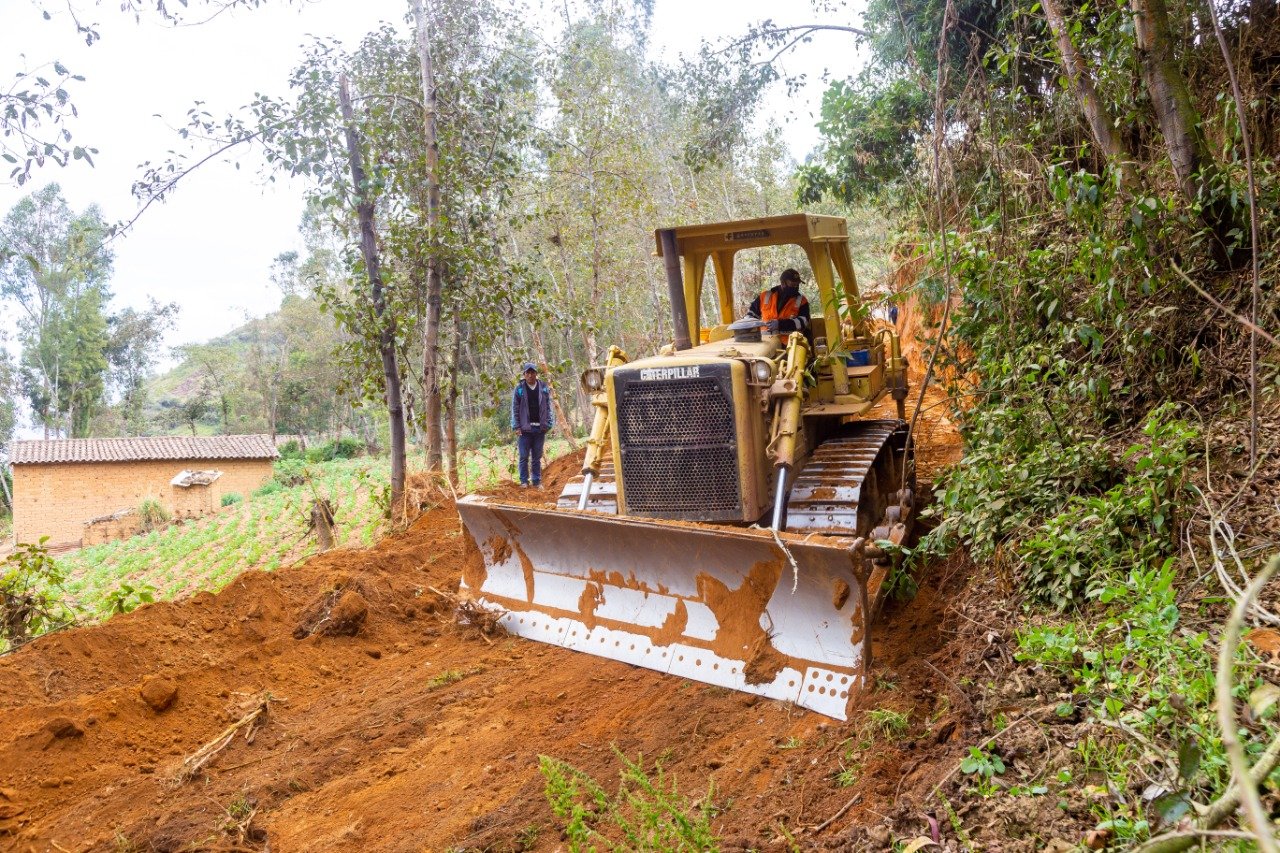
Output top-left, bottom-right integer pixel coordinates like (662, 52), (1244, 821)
(413, 0), (444, 471)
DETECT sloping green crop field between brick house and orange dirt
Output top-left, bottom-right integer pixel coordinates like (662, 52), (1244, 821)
(49, 439), (567, 620)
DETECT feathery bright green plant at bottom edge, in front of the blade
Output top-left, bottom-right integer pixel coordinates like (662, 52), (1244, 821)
(538, 748), (719, 853)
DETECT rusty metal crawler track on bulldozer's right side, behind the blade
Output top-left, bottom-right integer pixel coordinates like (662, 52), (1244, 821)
(786, 420), (914, 537)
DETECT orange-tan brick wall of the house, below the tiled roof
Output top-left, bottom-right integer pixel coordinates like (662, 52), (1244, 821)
(13, 459), (271, 546)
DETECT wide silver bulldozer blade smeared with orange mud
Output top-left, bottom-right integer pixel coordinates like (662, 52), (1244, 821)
(457, 496), (870, 720)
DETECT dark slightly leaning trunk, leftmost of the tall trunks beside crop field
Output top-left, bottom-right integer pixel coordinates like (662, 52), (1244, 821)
(338, 74), (404, 517)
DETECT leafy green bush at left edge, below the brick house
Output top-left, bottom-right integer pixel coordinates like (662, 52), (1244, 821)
(0, 537), (73, 647)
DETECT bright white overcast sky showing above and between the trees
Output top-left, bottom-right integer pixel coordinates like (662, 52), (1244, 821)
(0, 0), (861, 361)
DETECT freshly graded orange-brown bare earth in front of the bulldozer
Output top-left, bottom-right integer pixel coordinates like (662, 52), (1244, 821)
(0, 386), (1052, 853)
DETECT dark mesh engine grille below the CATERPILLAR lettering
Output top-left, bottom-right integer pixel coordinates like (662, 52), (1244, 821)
(613, 365), (741, 520)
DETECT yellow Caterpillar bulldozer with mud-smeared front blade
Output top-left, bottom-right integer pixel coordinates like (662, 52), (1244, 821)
(458, 214), (915, 720)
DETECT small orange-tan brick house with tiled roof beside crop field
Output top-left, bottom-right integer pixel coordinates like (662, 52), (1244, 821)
(9, 435), (279, 546)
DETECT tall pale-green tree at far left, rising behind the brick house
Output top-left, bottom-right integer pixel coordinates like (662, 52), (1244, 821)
(0, 184), (111, 437)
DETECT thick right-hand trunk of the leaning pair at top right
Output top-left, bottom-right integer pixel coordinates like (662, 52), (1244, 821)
(1132, 0), (1239, 269)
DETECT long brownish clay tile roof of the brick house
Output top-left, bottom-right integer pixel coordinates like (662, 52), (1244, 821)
(9, 435), (280, 465)
